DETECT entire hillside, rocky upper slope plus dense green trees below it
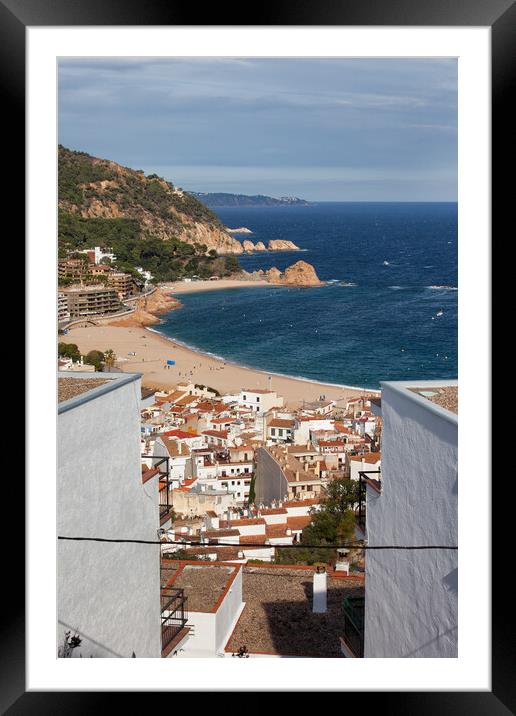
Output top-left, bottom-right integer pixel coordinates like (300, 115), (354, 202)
(58, 146), (240, 282)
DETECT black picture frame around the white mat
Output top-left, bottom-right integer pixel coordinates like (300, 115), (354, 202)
(10, 0), (510, 716)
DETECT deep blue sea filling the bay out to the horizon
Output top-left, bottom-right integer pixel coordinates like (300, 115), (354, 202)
(159, 202), (458, 388)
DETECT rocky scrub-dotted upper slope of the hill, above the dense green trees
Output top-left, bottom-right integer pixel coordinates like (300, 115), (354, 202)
(58, 147), (243, 254)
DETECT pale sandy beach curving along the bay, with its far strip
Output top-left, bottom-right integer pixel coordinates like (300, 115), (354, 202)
(59, 279), (375, 407)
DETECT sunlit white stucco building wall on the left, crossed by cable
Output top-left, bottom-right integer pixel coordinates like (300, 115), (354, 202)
(57, 374), (161, 658)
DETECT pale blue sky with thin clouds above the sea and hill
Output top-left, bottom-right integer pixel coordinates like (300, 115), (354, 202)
(59, 58), (457, 201)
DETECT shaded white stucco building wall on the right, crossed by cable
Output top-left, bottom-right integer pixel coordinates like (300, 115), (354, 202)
(364, 381), (458, 658)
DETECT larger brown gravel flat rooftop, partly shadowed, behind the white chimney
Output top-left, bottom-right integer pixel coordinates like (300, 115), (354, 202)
(226, 565), (364, 657)
